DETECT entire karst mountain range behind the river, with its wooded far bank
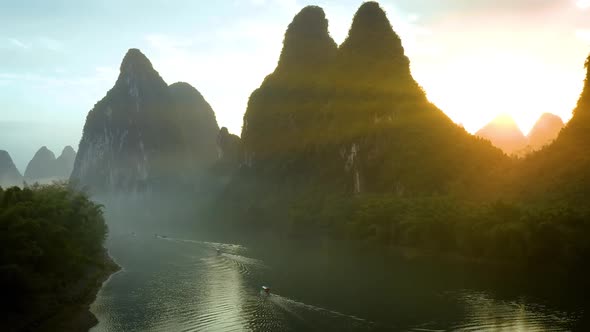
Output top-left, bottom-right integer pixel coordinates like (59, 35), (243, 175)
(0, 1), (590, 280)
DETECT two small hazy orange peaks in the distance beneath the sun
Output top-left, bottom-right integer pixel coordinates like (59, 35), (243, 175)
(475, 113), (565, 156)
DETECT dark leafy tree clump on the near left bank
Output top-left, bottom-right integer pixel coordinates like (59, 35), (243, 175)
(0, 184), (112, 330)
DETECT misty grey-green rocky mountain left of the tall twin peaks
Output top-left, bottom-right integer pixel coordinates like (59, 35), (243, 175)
(72, 49), (218, 192)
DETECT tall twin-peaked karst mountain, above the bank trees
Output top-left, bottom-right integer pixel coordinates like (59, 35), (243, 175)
(232, 2), (506, 202)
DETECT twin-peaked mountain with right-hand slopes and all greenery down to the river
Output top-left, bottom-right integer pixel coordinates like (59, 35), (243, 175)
(211, 2), (590, 269)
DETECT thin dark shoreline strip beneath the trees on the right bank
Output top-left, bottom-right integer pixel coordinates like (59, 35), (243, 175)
(204, 225), (590, 287)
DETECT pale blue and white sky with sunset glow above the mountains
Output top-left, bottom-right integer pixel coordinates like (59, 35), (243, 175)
(0, 0), (590, 171)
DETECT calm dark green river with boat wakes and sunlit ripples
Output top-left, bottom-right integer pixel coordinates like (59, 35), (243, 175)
(91, 224), (584, 332)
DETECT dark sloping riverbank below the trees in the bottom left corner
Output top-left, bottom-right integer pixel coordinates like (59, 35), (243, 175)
(3, 250), (120, 332)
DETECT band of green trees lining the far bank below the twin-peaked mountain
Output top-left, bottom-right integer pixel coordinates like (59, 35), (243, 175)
(289, 195), (590, 267)
